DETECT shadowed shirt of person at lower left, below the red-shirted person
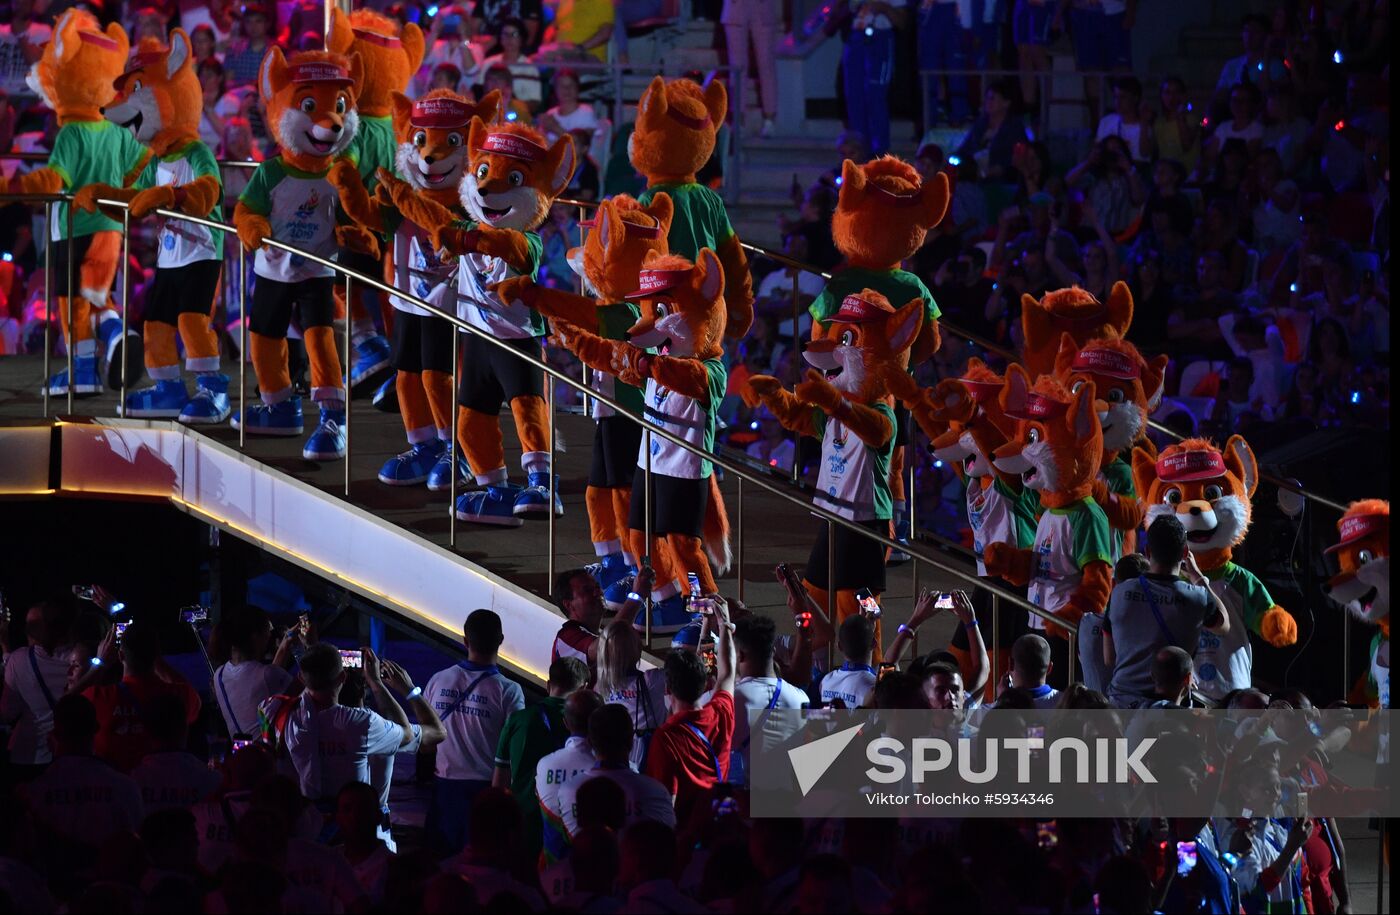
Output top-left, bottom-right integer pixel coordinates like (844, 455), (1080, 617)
(20, 756), (143, 845)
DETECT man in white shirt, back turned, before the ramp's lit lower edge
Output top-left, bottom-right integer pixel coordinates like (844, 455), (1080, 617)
(424, 610), (525, 855)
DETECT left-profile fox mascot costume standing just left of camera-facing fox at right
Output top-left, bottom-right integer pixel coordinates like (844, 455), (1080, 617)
(983, 365), (1113, 672)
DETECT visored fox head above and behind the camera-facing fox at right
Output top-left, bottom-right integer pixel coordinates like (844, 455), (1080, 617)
(1054, 333), (1168, 463)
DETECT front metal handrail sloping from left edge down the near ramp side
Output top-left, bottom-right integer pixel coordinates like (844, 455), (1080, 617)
(0, 194), (1078, 635)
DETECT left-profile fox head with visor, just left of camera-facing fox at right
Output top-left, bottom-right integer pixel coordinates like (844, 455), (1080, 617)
(993, 364), (1103, 508)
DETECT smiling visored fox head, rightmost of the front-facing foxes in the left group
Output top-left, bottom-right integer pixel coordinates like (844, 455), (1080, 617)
(458, 118), (577, 232)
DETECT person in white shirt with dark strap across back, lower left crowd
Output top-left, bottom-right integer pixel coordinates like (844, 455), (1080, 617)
(211, 607), (305, 737)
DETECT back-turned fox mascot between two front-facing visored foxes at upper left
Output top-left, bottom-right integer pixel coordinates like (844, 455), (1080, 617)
(326, 7), (424, 394)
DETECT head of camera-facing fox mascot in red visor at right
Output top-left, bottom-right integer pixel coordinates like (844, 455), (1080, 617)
(1133, 435), (1259, 559)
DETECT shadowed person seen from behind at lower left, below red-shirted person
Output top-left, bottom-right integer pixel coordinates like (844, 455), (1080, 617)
(21, 695), (141, 848)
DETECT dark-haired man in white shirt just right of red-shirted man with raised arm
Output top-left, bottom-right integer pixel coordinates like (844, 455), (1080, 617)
(728, 616), (812, 785)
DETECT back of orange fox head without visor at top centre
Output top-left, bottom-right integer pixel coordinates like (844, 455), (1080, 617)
(627, 76), (729, 185)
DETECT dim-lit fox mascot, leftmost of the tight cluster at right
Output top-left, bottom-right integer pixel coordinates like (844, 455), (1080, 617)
(913, 357), (1040, 695)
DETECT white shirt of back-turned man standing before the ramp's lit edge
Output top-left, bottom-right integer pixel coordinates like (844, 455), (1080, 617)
(423, 662), (525, 782)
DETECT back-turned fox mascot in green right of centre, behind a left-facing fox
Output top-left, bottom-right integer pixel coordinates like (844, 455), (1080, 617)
(809, 155), (951, 556)
